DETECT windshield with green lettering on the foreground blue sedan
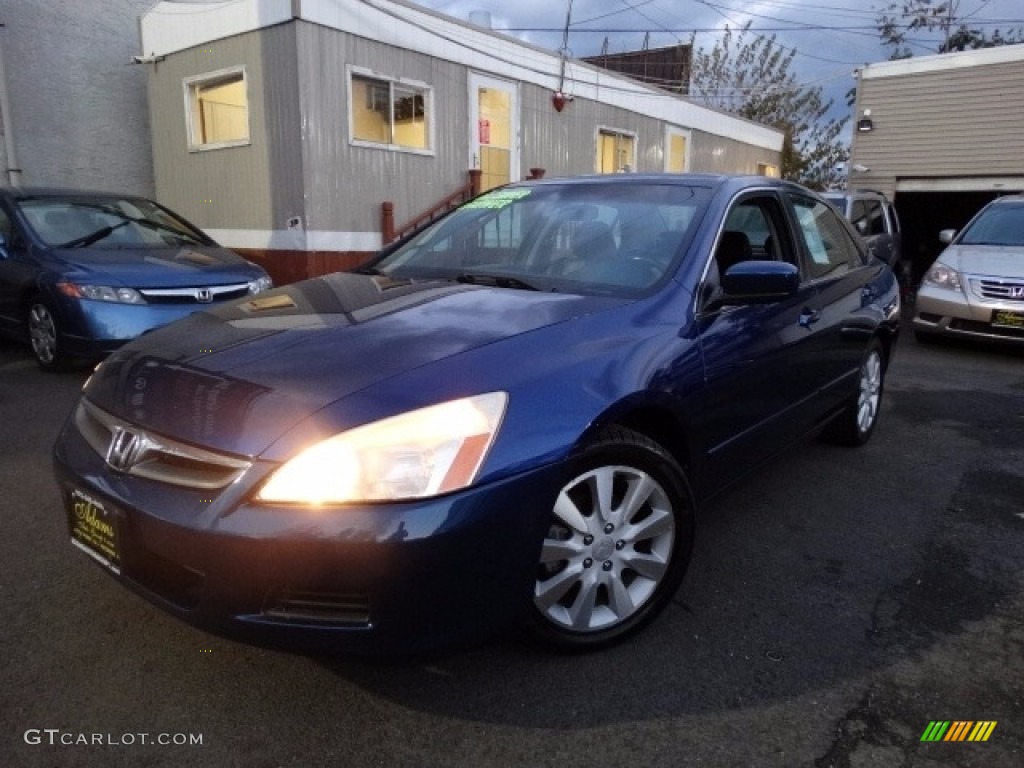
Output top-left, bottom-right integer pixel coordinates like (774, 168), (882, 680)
(371, 181), (710, 296)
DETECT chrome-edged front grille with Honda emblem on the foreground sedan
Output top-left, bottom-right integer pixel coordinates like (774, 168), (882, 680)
(75, 397), (252, 490)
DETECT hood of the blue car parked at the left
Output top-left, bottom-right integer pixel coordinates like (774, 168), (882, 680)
(52, 246), (262, 288)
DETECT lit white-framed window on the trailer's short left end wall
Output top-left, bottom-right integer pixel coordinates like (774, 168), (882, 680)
(184, 67), (249, 151)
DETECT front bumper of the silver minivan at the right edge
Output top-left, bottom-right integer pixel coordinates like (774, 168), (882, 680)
(913, 285), (1024, 344)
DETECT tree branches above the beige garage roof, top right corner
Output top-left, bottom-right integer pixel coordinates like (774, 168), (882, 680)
(876, 0), (1024, 58)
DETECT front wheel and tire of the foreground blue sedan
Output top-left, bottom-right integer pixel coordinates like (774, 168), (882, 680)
(529, 427), (694, 651)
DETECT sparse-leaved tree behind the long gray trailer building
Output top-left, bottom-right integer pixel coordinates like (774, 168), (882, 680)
(690, 22), (850, 189)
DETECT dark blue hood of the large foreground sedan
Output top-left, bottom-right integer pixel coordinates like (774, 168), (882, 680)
(85, 273), (627, 456)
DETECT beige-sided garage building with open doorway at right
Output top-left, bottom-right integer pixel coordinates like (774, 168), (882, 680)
(849, 45), (1024, 276)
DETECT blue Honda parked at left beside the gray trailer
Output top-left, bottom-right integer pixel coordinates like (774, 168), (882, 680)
(0, 188), (271, 370)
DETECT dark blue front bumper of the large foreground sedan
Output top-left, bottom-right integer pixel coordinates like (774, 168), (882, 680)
(54, 421), (564, 655)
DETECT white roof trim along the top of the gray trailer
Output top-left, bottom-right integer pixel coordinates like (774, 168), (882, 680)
(140, 0), (782, 152)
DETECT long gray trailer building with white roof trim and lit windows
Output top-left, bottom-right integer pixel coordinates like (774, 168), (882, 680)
(141, 0), (782, 281)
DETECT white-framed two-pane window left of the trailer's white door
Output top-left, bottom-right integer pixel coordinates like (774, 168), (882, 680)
(348, 67), (433, 154)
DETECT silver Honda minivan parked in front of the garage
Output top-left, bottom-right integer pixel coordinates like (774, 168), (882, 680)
(913, 195), (1024, 344)
